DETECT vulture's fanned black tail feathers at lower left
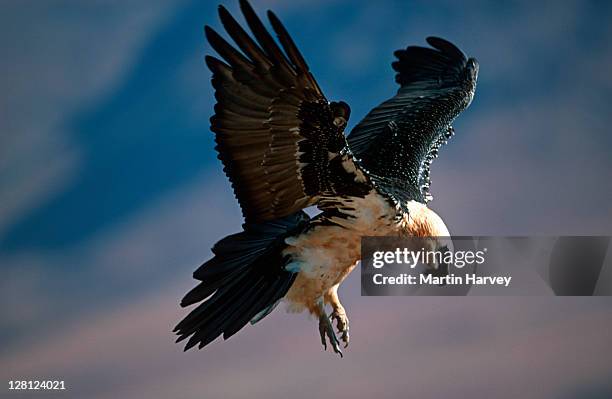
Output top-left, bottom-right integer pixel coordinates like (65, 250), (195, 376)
(174, 212), (309, 350)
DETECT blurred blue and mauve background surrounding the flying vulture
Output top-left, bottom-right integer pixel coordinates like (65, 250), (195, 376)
(0, 0), (612, 399)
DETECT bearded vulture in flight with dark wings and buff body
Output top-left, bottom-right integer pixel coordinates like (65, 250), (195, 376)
(174, 0), (478, 356)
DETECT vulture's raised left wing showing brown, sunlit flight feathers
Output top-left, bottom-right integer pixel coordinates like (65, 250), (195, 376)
(205, 0), (364, 222)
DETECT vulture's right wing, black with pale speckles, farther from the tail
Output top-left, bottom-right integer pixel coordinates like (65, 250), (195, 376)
(348, 37), (478, 205)
